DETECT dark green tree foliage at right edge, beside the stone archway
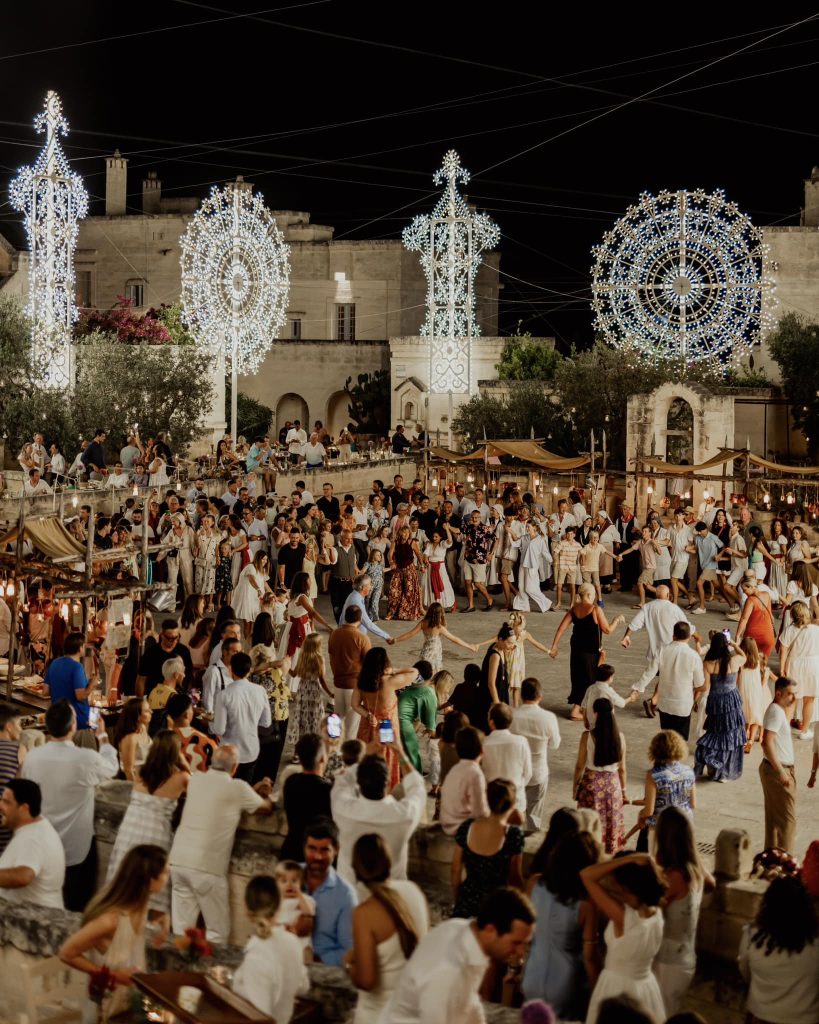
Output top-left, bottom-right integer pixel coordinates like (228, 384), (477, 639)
(768, 313), (819, 456)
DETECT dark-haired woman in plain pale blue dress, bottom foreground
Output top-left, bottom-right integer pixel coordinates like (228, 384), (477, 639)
(522, 831), (601, 1021)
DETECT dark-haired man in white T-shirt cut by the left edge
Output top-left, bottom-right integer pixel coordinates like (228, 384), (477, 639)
(0, 778), (66, 910)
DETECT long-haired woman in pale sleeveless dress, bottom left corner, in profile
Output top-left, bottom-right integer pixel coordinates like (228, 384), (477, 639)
(59, 845), (168, 1022)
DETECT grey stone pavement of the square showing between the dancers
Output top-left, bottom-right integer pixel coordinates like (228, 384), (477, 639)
(311, 592), (819, 864)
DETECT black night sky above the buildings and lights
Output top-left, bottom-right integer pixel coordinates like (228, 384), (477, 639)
(0, 0), (819, 350)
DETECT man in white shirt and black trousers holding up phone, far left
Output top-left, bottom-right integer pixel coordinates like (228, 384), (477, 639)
(20, 700), (120, 911)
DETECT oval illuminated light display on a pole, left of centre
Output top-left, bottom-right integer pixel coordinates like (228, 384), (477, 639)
(180, 177), (290, 440)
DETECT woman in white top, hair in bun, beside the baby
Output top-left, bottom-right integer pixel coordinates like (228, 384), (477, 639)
(233, 874), (310, 1024)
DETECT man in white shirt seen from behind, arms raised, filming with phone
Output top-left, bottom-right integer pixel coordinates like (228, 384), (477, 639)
(330, 742), (427, 886)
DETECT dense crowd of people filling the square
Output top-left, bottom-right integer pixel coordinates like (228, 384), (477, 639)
(0, 434), (819, 1024)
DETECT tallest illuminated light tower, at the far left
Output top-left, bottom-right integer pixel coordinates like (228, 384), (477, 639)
(8, 90), (88, 388)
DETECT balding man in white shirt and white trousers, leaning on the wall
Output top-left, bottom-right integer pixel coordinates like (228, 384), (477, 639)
(168, 743), (273, 942)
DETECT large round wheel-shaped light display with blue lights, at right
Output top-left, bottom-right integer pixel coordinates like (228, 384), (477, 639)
(592, 188), (774, 365)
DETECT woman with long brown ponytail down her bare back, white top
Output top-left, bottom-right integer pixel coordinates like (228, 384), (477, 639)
(344, 834), (429, 1024)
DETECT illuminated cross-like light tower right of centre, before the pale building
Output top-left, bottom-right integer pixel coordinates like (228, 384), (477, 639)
(403, 150), (501, 394)
